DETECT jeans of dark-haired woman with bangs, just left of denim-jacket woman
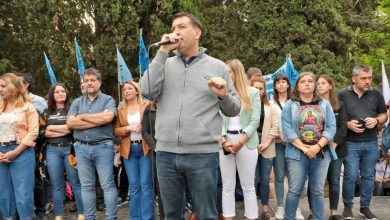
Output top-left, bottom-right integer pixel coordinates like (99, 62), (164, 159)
(273, 143), (286, 207)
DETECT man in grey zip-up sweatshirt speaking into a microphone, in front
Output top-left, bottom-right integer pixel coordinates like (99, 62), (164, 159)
(141, 12), (241, 220)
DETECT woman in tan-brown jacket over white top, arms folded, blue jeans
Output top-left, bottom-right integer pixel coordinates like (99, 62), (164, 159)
(114, 81), (154, 219)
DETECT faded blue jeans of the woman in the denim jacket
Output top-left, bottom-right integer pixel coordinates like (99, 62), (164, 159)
(284, 150), (331, 220)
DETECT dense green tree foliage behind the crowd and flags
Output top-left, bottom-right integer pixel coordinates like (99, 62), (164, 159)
(0, 0), (390, 97)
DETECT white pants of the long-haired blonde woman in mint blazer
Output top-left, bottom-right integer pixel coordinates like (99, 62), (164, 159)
(219, 134), (258, 219)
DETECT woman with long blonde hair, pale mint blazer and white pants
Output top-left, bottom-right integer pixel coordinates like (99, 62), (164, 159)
(219, 59), (261, 219)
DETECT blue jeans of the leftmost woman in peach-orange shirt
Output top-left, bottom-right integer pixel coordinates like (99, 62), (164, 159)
(0, 145), (35, 220)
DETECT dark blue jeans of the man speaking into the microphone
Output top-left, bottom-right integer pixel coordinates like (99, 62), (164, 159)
(157, 152), (218, 220)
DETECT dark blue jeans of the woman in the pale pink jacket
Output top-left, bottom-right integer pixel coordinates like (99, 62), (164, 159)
(257, 155), (274, 205)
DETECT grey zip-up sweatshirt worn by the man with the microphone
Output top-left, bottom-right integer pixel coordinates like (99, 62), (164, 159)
(141, 48), (241, 154)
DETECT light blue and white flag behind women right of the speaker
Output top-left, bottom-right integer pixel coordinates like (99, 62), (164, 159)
(264, 55), (299, 100)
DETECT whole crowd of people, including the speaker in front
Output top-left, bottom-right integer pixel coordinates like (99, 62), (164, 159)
(0, 13), (390, 220)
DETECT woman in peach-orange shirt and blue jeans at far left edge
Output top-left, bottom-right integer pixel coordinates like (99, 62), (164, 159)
(0, 73), (39, 219)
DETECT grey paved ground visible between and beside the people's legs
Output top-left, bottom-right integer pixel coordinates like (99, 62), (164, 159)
(35, 196), (390, 220)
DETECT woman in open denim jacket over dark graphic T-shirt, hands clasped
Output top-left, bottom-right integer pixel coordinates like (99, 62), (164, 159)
(282, 72), (336, 220)
